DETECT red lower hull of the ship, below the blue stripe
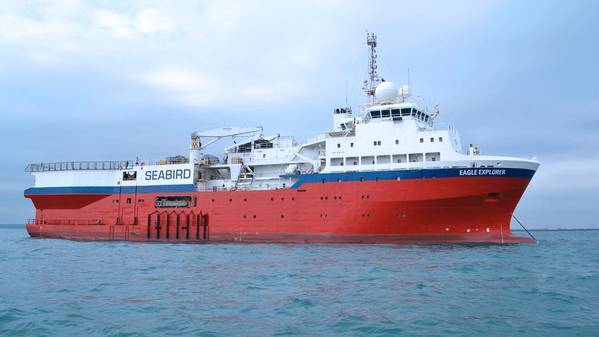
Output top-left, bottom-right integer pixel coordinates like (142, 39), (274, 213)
(25, 172), (534, 243)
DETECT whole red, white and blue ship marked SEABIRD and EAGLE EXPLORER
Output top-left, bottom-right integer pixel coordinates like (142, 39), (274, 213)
(25, 35), (539, 243)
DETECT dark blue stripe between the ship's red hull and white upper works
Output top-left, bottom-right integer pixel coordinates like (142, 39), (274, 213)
(25, 168), (535, 195)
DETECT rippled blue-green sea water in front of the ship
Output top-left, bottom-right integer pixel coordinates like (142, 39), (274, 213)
(0, 228), (599, 336)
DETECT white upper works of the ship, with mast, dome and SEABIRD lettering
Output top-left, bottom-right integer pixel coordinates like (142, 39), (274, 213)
(28, 35), (538, 191)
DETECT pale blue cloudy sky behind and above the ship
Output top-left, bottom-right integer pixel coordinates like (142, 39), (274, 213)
(0, 0), (599, 228)
